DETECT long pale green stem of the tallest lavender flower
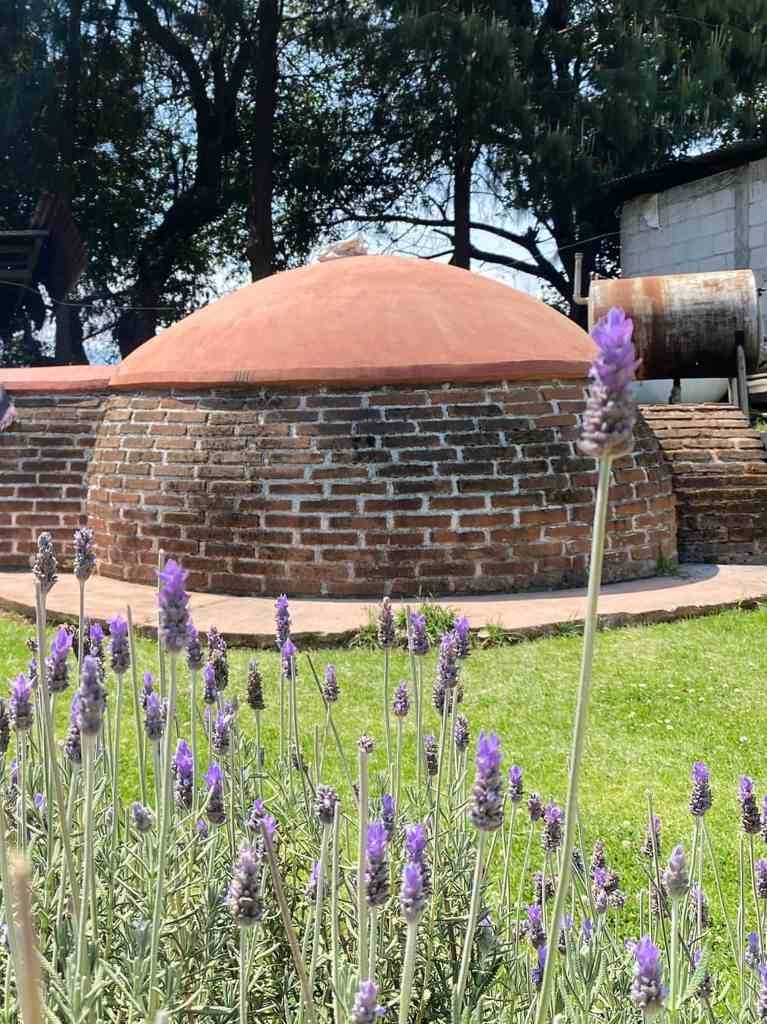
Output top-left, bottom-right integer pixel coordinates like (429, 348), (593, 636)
(536, 456), (612, 1024)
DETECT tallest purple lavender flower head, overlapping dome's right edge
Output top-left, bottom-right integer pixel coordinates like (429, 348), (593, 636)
(579, 307), (639, 459)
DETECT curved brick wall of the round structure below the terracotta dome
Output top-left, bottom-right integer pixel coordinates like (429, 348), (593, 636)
(80, 382), (676, 596)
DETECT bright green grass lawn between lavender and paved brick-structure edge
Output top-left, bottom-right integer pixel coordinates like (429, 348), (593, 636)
(0, 608), (767, 958)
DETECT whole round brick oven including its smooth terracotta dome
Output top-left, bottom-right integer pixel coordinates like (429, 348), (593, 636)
(0, 256), (676, 596)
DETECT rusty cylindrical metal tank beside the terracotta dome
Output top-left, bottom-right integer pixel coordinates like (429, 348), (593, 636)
(589, 270), (762, 380)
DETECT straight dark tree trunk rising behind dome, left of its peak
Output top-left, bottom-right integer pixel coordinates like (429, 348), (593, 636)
(248, 0), (281, 281)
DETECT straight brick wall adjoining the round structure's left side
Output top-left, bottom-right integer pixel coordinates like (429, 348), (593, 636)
(0, 393), (105, 567)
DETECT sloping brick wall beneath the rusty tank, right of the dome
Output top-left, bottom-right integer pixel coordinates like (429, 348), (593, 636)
(643, 404), (767, 565)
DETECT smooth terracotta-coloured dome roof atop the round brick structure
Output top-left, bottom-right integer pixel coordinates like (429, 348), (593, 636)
(111, 256), (594, 388)
